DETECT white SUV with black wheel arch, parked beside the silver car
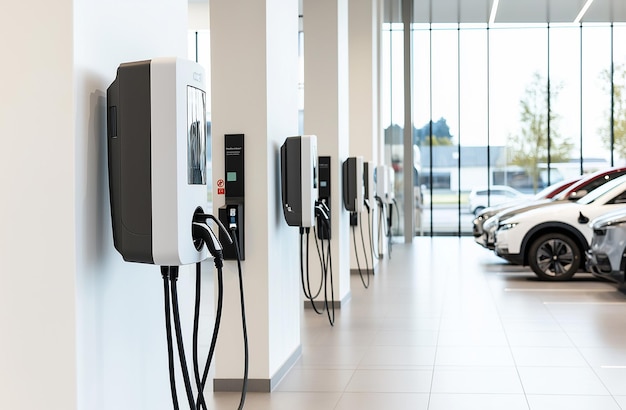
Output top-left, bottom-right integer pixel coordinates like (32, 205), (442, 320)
(495, 176), (626, 280)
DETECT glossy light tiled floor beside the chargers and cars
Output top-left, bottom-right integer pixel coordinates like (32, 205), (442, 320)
(210, 237), (626, 410)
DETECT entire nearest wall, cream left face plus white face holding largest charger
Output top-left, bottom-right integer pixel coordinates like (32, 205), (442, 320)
(0, 0), (195, 410)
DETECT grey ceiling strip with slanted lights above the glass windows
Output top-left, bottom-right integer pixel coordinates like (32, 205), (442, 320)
(384, 0), (626, 24)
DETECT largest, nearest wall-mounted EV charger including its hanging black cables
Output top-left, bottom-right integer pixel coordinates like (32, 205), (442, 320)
(107, 57), (248, 409)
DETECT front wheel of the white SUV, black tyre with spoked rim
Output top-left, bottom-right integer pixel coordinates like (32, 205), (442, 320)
(528, 233), (581, 280)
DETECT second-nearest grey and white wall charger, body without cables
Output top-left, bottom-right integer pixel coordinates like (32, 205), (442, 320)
(280, 135), (318, 228)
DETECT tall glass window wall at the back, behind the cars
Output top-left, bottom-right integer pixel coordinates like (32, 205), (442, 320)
(382, 1), (626, 235)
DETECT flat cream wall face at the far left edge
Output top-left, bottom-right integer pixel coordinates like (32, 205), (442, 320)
(0, 0), (76, 410)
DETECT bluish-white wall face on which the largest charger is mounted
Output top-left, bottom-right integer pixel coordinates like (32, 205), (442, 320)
(74, 0), (189, 409)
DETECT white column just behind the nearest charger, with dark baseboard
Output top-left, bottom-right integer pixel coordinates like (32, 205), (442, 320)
(210, 0), (301, 391)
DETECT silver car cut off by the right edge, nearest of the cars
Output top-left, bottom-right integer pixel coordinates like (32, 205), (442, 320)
(586, 207), (626, 286)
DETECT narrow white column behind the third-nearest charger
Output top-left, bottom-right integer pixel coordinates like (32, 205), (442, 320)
(349, 0), (381, 273)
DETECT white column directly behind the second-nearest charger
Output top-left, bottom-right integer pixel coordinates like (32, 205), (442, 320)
(303, 0), (350, 306)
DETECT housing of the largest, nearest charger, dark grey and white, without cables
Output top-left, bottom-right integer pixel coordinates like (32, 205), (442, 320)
(107, 57), (208, 266)
